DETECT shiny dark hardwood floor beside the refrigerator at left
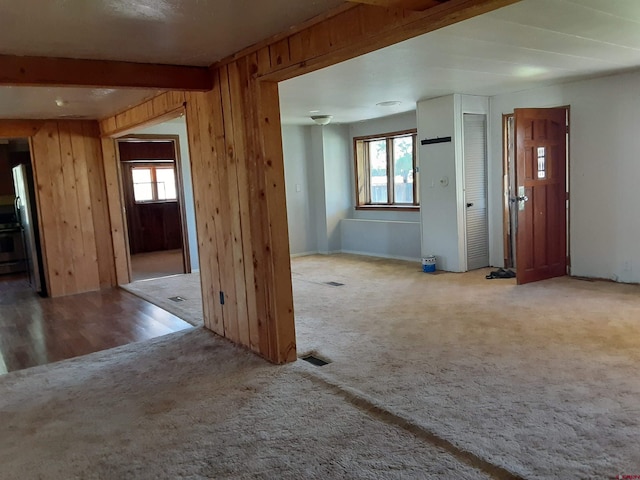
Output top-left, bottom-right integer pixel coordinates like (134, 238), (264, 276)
(0, 276), (193, 374)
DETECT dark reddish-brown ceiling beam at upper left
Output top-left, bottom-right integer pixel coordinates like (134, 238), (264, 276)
(0, 55), (213, 91)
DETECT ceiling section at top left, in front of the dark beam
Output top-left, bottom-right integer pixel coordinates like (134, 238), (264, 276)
(0, 0), (344, 66)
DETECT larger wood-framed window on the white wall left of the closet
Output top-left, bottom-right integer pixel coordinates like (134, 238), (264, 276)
(353, 130), (420, 208)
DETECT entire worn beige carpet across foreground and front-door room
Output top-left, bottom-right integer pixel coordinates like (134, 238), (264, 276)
(0, 255), (640, 479)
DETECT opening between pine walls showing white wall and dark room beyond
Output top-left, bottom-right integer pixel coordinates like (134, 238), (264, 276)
(116, 114), (203, 326)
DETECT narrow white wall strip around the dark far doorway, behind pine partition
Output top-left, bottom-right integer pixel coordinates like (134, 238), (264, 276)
(135, 117), (200, 272)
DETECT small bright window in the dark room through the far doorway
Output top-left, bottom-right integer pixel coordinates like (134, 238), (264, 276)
(131, 164), (177, 203)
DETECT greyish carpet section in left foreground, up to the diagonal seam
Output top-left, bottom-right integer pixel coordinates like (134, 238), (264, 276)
(0, 328), (491, 480)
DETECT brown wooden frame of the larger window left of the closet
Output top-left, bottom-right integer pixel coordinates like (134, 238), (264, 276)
(353, 128), (420, 211)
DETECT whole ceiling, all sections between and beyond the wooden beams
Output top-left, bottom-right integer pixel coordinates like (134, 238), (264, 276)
(0, 0), (640, 123)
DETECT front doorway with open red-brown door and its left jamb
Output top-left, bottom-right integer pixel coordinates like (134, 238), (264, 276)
(502, 106), (570, 283)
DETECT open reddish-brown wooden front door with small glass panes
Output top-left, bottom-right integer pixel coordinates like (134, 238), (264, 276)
(514, 108), (567, 284)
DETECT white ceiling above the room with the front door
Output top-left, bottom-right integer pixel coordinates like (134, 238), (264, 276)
(280, 0), (640, 124)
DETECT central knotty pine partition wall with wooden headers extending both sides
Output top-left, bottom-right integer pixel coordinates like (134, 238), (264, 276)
(101, 0), (517, 363)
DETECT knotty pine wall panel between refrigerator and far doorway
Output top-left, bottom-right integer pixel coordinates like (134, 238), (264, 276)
(31, 121), (115, 297)
